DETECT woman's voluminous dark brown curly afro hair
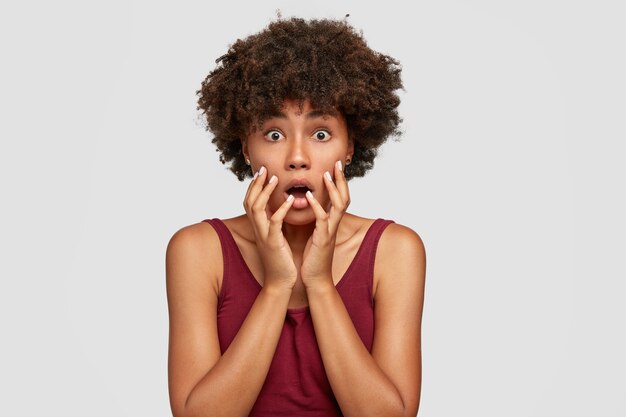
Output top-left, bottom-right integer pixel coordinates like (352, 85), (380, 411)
(196, 18), (403, 181)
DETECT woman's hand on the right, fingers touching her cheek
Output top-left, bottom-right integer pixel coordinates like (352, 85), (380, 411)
(300, 161), (350, 289)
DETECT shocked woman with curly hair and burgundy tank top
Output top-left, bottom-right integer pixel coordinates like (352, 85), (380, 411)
(166, 18), (426, 417)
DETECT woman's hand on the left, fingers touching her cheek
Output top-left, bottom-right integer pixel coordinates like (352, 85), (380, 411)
(243, 166), (298, 290)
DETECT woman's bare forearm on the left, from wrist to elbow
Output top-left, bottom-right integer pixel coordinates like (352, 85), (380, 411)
(179, 288), (291, 417)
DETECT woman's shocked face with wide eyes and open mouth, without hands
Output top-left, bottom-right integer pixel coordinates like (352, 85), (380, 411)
(242, 100), (354, 225)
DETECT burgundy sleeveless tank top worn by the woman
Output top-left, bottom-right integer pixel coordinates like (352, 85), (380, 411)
(203, 219), (393, 417)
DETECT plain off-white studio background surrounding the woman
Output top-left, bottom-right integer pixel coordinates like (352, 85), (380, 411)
(0, 0), (626, 417)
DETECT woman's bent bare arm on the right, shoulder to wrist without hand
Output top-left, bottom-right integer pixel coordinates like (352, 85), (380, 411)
(307, 224), (426, 417)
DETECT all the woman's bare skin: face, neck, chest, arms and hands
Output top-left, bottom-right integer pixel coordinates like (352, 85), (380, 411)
(166, 102), (426, 417)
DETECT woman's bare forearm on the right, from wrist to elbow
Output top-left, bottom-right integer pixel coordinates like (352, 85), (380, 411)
(307, 285), (405, 417)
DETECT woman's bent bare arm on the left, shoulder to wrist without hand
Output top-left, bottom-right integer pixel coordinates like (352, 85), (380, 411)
(166, 225), (291, 417)
